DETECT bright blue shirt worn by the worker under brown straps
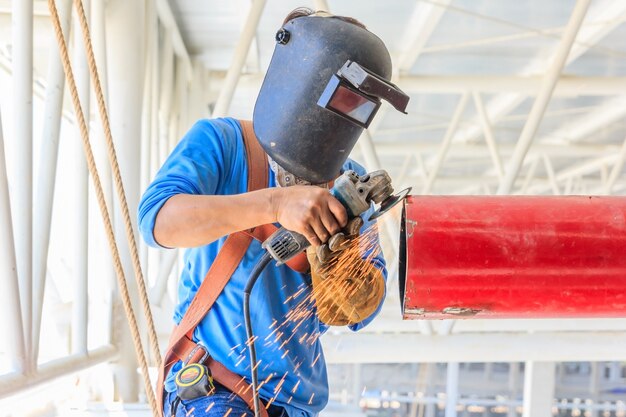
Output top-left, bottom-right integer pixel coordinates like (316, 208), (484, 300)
(139, 118), (386, 417)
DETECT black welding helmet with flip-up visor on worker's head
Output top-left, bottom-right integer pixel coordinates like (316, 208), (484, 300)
(253, 16), (409, 184)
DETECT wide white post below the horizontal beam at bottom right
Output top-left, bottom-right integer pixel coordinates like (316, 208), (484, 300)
(522, 361), (556, 417)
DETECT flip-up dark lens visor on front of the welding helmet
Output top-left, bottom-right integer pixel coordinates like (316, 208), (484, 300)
(317, 60), (409, 129)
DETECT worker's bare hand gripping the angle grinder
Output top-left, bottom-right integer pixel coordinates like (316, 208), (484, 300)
(271, 185), (348, 247)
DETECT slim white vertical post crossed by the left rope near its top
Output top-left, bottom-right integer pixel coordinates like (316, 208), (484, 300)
(72, 0), (91, 354)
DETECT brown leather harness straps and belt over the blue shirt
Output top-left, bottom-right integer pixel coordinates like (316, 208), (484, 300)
(157, 121), (309, 417)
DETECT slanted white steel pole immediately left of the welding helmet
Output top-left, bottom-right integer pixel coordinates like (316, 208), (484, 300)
(213, 0), (266, 117)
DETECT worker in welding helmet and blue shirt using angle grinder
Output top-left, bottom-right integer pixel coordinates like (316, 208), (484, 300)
(139, 9), (400, 417)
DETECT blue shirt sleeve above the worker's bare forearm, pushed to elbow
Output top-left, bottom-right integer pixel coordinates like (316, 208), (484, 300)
(138, 119), (236, 247)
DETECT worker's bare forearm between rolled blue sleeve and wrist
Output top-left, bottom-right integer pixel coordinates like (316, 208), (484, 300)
(154, 189), (276, 248)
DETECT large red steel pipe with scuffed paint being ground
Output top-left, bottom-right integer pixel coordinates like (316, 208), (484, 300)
(400, 196), (626, 319)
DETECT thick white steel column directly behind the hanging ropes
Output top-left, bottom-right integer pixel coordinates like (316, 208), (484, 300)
(106, 0), (145, 401)
